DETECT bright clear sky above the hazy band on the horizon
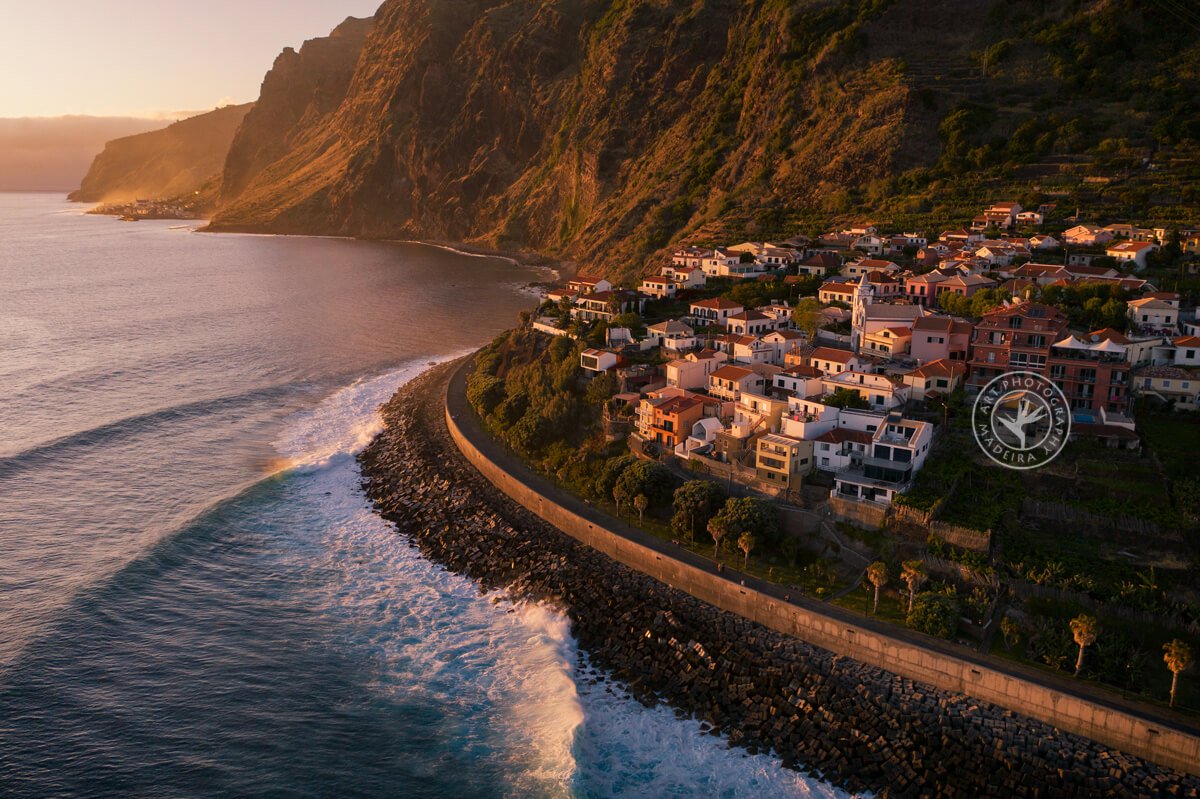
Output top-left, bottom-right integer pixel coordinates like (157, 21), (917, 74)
(0, 0), (382, 119)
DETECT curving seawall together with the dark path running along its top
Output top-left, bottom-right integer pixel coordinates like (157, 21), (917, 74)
(445, 359), (1200, 774)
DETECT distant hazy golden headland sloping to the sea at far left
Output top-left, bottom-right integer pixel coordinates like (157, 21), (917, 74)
(70, 103), (251, 203)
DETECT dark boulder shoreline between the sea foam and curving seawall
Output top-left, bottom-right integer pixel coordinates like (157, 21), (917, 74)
(359, 364), (1200, 797)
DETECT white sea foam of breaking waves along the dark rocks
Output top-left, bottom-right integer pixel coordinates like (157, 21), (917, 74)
(277, 364), (844, 798)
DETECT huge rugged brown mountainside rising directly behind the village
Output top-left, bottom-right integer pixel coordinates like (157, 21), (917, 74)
(212, 0), (1200, 275)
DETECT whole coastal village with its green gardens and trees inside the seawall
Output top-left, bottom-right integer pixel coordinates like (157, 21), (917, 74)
(466, 202), (1200, 703)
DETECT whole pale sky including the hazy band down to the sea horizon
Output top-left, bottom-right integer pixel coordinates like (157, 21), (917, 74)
(0, 0), (380, 192)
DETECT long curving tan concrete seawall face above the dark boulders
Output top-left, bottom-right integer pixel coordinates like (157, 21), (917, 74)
(445, 364), (1200, 774)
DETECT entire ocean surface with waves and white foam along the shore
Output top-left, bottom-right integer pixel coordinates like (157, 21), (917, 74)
(0, 194), (841, 799)
